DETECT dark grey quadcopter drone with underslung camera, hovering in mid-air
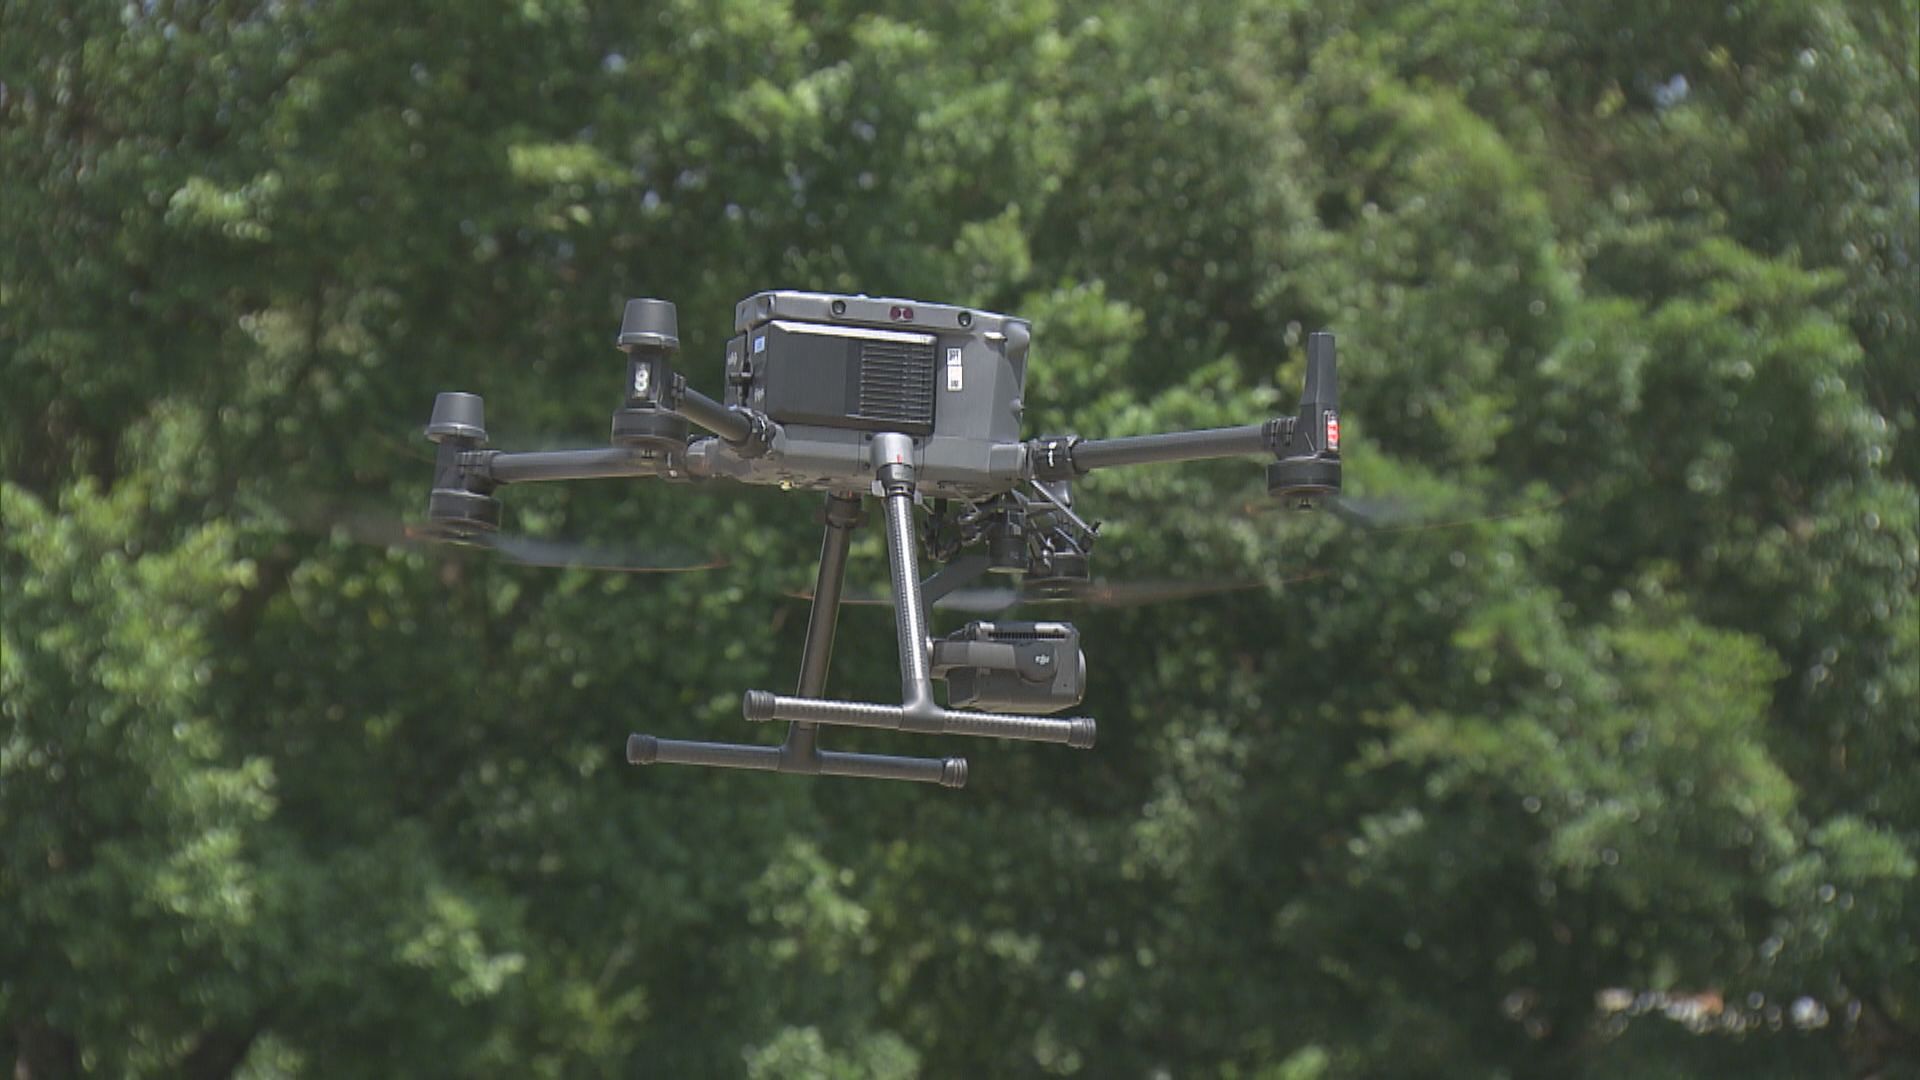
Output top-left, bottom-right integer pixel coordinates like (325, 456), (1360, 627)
(426, 290), (1340, 788)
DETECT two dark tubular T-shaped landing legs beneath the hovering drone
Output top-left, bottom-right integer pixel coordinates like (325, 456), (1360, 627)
(626, 434), (1094, 788)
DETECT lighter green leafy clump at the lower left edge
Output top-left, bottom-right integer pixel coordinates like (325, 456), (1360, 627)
(0, 480), (275, 1070)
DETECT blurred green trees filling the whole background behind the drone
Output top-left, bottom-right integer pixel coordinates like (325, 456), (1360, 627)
(0, 0), (1920, 1080)
